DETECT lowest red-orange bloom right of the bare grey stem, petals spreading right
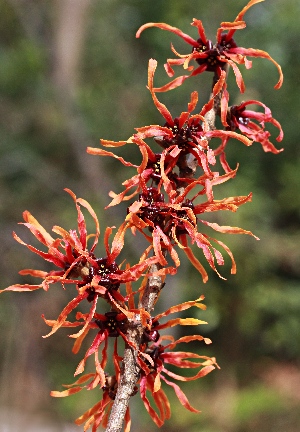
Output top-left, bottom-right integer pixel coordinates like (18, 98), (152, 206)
(139, 296), (218, 426)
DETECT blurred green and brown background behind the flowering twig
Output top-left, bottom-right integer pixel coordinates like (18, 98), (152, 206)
(0, 0), (300, 432)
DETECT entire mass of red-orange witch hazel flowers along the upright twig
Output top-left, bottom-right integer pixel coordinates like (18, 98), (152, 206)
(2, 0), (283, 432)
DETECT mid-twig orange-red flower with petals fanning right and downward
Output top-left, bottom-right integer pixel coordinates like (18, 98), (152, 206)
(126, 181), (257, 282)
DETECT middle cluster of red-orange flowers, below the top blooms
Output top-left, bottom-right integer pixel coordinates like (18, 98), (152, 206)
(87, 59), (260, 282)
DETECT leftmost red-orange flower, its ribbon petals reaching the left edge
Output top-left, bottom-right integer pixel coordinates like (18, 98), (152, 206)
(1, 190), (158, 337)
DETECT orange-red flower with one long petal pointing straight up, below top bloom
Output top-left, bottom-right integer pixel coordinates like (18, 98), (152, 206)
(136, 59), (251, 194)
